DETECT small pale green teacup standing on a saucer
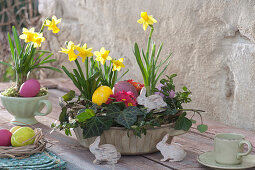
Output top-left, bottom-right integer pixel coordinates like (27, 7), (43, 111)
(214, 133), (252, 165)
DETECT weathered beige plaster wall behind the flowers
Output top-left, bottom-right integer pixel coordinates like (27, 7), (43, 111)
(39, 0), (255, 129)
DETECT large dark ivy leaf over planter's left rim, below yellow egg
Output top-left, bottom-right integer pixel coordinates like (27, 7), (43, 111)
(83, 116), (113, 139)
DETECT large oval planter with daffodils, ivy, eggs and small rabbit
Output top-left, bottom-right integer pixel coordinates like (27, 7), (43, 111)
(52, 12), (207, 155)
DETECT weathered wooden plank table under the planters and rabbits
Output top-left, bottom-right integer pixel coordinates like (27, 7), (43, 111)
(0, 79), (255, 170)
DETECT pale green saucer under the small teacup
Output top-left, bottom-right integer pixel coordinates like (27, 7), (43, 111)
(197, 152), (255, 169)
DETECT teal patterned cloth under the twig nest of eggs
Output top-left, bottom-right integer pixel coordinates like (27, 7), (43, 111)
(0, 151), (66, 170)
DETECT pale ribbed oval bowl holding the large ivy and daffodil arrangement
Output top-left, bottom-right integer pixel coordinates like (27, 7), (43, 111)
(74, 124), (186, 155)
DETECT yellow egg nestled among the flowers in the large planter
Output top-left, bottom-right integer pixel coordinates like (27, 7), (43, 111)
(92, 86), (112, 106)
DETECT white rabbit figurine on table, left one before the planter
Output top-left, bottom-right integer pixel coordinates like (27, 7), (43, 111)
(89, 136), (121, 164)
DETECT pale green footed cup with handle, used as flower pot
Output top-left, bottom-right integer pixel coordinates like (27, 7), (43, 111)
(0, 94), (52, 125)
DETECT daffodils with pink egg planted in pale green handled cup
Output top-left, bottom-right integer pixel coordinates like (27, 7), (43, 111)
(0, 16), (61, 125)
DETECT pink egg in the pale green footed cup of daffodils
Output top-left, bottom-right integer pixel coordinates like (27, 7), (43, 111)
(19, 79), (40, 97)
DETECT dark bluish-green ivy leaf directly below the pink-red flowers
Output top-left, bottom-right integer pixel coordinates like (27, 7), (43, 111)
(115, 106), (143, 129)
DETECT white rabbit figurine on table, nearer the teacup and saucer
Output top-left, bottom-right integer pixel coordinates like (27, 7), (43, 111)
(156, 134), (186, 162)
